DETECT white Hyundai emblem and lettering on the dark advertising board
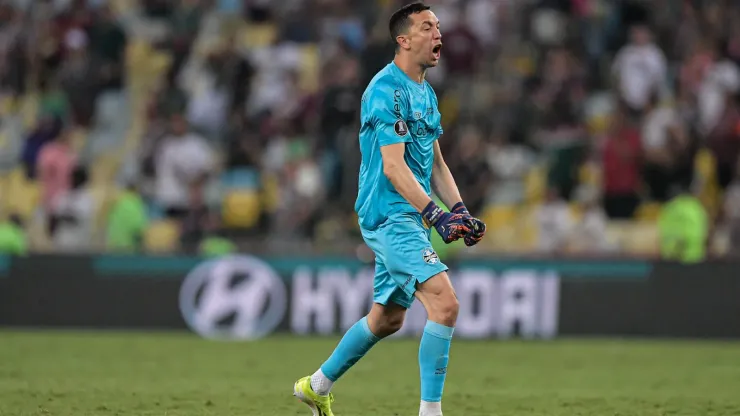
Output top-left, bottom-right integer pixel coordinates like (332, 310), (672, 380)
(180, 256), (559, 339)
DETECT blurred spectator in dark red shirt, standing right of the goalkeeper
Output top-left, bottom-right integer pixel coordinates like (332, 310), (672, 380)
(603, 105), (642, 219)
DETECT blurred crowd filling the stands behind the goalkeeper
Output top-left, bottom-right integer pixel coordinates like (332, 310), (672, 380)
(0, 0), (740, 260)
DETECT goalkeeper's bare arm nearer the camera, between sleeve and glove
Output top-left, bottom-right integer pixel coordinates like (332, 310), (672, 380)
(380, 143), (432, 212)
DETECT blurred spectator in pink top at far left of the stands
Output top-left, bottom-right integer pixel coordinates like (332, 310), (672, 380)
(37, 130), (77, 213)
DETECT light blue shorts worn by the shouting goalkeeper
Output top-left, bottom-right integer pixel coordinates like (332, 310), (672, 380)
(362, 213), (447, 309)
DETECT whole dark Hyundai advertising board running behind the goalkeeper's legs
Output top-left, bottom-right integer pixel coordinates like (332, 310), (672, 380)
(0, 256), (740, 340)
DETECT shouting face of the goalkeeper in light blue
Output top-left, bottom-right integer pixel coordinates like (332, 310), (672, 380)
(406, 10), (442, 68)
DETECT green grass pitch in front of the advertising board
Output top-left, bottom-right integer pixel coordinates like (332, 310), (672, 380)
(0, 331), (740, 416)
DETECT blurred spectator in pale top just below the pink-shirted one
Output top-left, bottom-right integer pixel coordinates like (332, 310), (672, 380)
(49, 167), (97, 252)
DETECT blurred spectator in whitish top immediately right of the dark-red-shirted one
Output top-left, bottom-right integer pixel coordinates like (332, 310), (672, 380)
(641, 94), (691, 202)
